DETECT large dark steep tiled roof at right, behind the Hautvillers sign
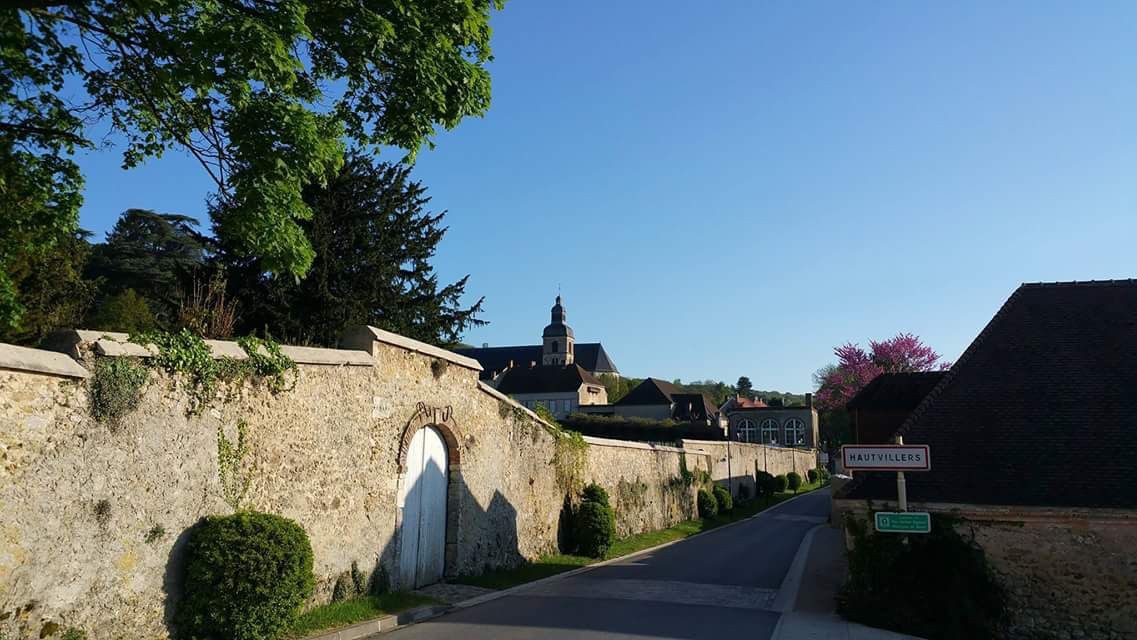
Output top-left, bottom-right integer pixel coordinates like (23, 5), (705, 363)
(841, 280), (1137, 509)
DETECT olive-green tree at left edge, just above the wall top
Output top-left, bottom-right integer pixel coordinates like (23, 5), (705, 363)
(0, 232), (96, 344)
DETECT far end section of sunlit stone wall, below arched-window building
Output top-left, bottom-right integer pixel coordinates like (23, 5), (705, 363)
(682, 440), (819, 496)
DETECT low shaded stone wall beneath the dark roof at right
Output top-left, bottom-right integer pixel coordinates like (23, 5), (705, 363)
(833, 499), (1137, 640)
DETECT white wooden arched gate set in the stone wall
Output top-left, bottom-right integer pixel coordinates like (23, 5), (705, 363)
(399, 426), (448, 589)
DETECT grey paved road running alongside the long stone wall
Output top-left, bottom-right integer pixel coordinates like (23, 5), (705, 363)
(390, 491), (829, 640)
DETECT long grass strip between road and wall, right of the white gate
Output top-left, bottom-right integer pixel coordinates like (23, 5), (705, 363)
(454, 483), (822, 589)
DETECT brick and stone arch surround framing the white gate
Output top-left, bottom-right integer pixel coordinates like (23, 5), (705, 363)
(395, 402), (463, 589)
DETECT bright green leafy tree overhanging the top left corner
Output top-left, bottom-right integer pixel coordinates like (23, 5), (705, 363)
(0, 0), (503, 324)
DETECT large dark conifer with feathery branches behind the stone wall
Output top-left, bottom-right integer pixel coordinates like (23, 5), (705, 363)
(213, 156), (485, 346)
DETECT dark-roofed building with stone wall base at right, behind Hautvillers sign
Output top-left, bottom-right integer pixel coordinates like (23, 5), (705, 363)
(833, 280), (1137, 638)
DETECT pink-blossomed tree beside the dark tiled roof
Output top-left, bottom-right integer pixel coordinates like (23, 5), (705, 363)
(815, 333), (952, 412)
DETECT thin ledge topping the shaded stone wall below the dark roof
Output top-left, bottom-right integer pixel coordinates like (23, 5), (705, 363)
(833, 497), (1137, 526)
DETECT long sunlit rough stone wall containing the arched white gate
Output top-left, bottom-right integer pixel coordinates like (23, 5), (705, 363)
(0, 334), (707, 640)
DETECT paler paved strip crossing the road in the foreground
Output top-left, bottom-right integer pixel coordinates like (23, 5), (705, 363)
(517, 577), (778, 612)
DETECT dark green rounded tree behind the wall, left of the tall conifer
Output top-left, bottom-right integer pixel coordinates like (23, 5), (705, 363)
(88, 209), (208, 322)
